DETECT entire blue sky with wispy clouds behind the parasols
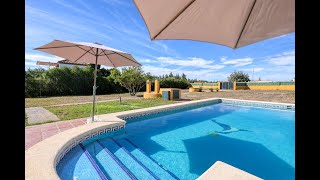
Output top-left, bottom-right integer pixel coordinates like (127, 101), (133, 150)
(25, 0), (295, 81)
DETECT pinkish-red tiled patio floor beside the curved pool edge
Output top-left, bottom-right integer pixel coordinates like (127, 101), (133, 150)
(25, 118), (87, 150)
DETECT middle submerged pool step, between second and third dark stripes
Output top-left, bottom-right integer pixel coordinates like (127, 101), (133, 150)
(99, 138), (159, 179)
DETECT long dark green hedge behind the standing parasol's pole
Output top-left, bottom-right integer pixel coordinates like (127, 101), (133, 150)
(25, 66), (127, 97)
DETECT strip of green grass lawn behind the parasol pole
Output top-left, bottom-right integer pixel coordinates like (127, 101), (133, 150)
(46, 98), (175, 120)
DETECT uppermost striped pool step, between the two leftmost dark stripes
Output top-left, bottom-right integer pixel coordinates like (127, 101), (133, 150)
(85, 141), (137, 180)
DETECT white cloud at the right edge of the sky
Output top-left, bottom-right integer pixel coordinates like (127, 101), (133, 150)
(266, 51), (295, 66)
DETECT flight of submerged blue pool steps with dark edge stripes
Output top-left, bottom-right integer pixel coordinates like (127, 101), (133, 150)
(80, 138), (179, 180)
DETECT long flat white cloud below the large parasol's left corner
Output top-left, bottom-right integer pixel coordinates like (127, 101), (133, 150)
(157, 57), (224, 69)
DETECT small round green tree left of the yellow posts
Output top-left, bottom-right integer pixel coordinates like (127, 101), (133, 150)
(110, 67), (146, 96)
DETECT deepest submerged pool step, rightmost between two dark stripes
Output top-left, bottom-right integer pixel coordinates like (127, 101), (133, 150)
(115, 138), (179, 180)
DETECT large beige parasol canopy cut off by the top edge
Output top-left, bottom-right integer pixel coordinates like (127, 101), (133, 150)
(133, 0), (295, 49)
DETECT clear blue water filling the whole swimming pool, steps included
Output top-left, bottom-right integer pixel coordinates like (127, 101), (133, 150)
(57, 103), (295, 180)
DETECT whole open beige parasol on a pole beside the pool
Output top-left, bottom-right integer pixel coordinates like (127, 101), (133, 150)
(35, 40), (141, 122)
